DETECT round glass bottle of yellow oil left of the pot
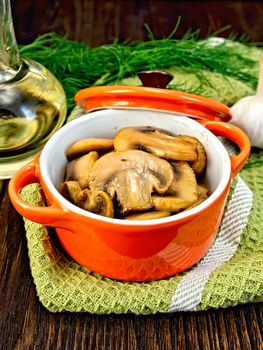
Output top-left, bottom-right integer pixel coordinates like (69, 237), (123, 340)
(0, 0), (66, 179)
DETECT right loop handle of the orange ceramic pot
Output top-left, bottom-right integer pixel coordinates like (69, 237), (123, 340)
(198, 120), (251, 177)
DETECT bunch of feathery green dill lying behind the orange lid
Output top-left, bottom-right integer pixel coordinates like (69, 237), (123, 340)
(20, 31), (262, 110)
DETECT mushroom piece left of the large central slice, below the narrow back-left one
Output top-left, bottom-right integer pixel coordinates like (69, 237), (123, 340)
(65, 151), (99, 189)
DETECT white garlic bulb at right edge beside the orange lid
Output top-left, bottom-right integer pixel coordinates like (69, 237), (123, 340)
(230, 57), (263, 149)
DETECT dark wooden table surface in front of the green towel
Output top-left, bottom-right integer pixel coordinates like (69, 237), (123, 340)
(0, 181), (263, 350)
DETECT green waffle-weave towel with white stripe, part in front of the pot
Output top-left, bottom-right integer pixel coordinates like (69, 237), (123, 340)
(19, 150), (263, 314)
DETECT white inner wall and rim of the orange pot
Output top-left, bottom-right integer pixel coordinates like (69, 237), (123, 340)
(40, 109), (231, 225)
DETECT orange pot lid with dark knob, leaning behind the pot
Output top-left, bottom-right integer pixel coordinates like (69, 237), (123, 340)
(75, 71), (232, 122)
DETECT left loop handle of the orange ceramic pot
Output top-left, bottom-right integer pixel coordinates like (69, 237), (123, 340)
(8, 157), (67, 226)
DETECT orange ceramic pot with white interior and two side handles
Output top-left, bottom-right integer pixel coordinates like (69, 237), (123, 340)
(9, 89), (250, 281)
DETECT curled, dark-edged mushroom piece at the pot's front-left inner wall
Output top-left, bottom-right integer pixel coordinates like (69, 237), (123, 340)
(59, 181), (114, 218)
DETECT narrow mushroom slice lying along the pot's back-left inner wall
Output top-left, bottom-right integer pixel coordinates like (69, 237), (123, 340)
(66, 138), (113, 160)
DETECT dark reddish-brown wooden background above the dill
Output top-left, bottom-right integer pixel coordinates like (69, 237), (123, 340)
(11, 0), (263, 46)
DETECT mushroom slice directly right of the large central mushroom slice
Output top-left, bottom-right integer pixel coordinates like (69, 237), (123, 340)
(152, 162), (198, 212)
